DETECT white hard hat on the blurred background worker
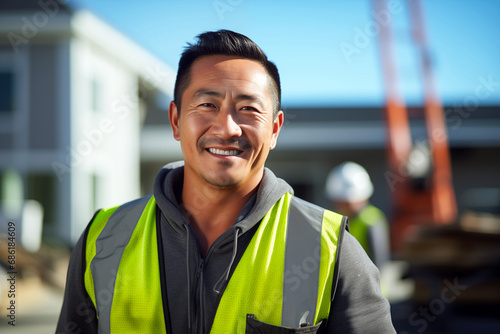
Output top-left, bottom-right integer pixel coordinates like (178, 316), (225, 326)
(326, 161), (373, 202)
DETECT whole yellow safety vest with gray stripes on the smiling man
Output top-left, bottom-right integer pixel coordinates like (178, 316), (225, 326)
(85, 193), (344, 333)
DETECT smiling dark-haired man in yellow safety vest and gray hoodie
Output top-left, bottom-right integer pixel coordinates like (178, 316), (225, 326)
(57, 30), (394, 333)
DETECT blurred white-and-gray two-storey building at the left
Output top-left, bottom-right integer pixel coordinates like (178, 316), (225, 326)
(0, 0), (175, 244)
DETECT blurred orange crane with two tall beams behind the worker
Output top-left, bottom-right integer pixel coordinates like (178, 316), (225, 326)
(373, 0), (457, 252)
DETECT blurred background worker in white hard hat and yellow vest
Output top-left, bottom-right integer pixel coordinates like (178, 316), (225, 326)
(326, 161), (390, 269)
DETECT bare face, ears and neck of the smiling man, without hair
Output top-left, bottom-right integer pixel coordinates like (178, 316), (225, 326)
(169, 55), (283, 255)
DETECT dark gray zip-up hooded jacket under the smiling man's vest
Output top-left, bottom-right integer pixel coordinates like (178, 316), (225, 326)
(57, 163), (395, 333)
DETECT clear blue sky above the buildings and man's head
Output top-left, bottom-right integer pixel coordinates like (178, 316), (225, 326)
(74, 0), (500, 107)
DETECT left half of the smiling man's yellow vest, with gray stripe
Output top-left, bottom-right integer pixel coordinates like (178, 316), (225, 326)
(85, 196), (165, 333)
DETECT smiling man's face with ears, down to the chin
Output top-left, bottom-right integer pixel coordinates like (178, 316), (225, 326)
(169, 55), (283, 189)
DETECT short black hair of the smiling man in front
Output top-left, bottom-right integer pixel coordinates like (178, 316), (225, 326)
(174, 30), (281, 116)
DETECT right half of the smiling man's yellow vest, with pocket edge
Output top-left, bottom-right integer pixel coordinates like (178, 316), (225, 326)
(212, 194), (342, 333)
